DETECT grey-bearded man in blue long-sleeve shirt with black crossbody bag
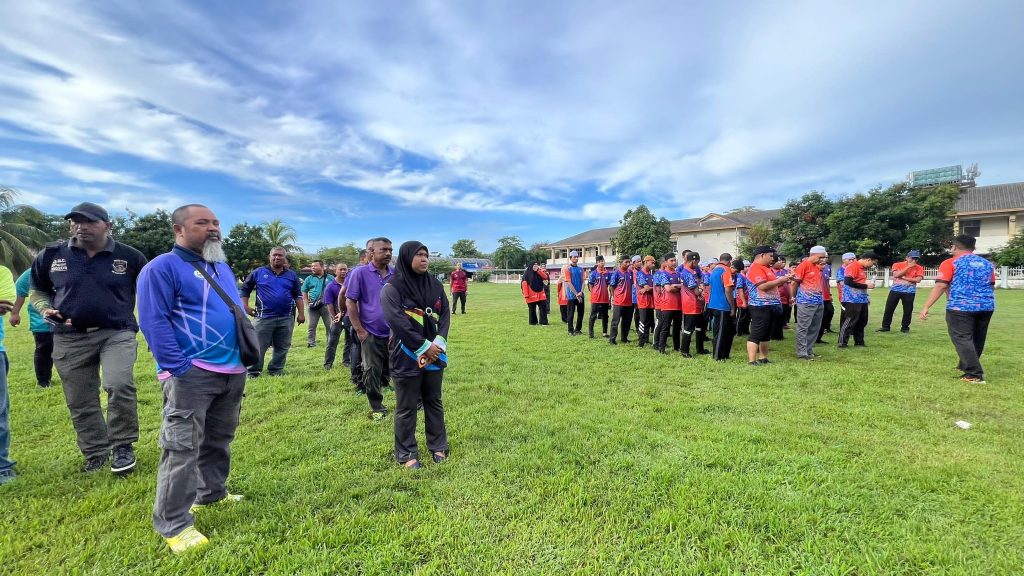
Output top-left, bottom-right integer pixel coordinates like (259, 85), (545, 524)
(138, 204), (246, 553)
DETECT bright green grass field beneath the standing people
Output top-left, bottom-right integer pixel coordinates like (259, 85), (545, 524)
(0, 285), (1024, 575)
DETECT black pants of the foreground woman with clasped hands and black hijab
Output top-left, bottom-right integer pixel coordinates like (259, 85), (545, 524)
(394, 370), (449, 463)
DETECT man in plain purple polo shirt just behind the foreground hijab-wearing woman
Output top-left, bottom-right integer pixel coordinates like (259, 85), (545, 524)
(345, 238), (394, 421)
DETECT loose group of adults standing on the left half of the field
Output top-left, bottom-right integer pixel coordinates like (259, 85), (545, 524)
(0, 202), (456, 552)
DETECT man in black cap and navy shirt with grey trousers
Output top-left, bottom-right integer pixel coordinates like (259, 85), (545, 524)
(29, 202), (146, 475)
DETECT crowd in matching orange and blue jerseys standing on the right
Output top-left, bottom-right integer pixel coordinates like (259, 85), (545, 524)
(521, 236), (995, 382)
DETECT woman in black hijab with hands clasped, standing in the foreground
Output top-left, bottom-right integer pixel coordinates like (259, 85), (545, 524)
(381, 240), (451, 468)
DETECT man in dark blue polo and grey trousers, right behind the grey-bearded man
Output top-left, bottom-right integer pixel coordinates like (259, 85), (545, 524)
(239, 246), (306, 378)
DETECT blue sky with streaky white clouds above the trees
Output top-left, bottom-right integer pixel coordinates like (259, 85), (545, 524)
(0, 0), (1024, 253)
